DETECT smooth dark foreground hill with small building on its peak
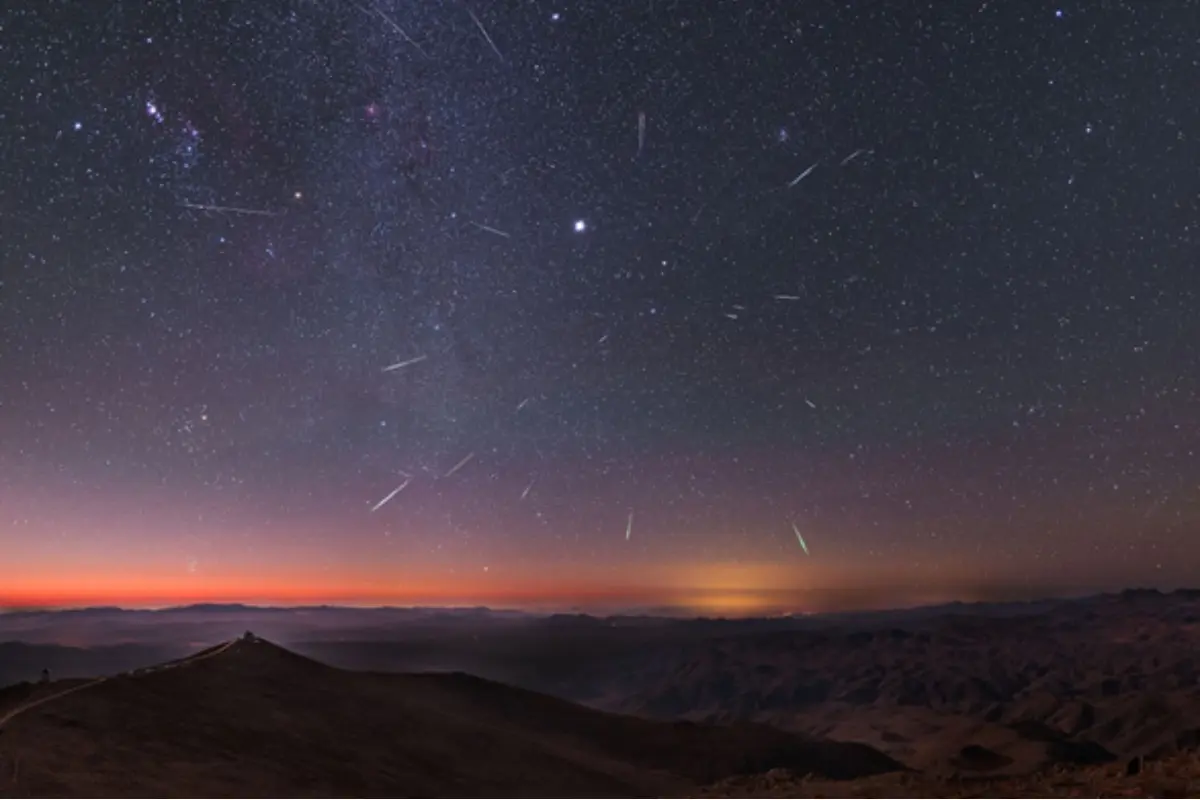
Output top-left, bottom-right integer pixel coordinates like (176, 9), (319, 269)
(0, 637), (901, 796)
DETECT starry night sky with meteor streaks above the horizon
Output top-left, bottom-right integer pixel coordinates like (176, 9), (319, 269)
(0, 0), (1200, 613)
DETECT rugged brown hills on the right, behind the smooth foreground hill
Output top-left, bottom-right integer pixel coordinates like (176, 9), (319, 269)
(560, 590), (1200, 775)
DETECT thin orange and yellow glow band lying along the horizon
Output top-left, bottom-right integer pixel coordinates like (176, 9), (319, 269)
(0, 563), (1099, 616)
